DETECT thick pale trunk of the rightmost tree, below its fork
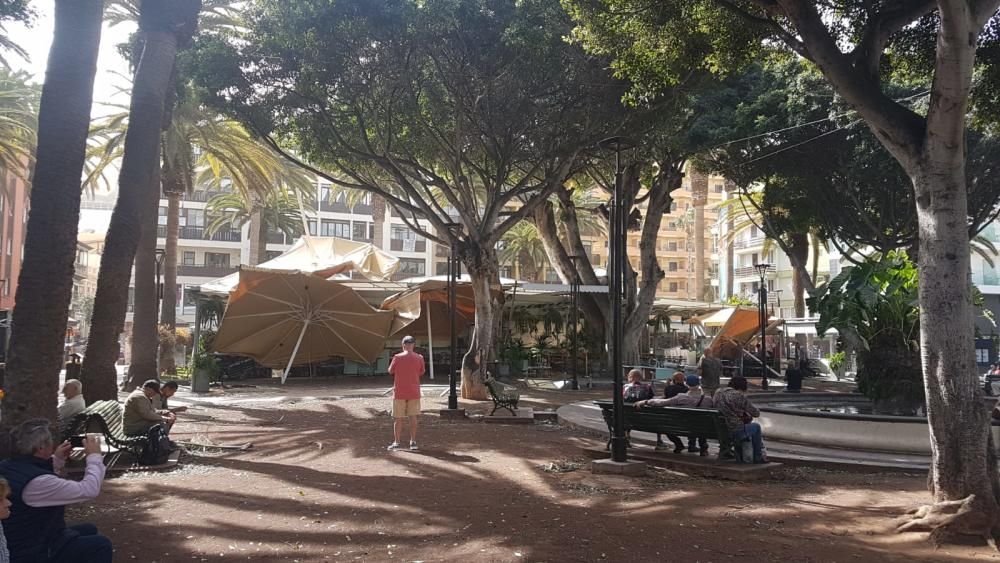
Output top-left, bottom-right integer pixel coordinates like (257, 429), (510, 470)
(913, 164), (1000, 539)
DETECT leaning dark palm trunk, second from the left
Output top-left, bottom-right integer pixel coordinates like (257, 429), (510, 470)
(81, 26), (177, 402)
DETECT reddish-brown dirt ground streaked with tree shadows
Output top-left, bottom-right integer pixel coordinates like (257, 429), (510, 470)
(74, 378), (1000, 563)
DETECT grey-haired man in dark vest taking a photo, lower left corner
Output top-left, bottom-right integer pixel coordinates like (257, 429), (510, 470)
(0, 419), (113, 563)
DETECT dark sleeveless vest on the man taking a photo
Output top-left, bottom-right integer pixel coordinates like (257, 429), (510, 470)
(0, 456), (70, 563)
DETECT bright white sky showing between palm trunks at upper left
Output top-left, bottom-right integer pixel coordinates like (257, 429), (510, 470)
(5, 0), (136, 232)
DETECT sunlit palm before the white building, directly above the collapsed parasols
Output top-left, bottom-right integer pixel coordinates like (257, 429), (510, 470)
(205, 185), (311, 266)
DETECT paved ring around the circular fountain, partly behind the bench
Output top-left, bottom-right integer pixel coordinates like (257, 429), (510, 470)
(556, 401), (930, 472)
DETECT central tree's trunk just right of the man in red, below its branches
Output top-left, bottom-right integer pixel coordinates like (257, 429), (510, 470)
(459, 244), (502, 401)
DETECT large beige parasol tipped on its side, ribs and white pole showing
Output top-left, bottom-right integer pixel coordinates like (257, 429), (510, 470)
(213, 266), (396, 382)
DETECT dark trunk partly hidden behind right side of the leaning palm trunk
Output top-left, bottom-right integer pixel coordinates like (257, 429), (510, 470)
(121, 164), (160, 392)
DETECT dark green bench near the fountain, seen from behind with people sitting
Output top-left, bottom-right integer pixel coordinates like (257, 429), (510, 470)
(594, 401), (733, 459)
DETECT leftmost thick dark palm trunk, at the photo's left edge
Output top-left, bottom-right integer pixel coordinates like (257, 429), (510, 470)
(0, 0), (104, 432)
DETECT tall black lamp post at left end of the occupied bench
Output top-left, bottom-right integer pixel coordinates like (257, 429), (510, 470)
(597, 137), (635, 462)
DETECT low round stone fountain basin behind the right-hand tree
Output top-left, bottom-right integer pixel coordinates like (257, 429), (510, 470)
(750, 393), (1000, 455)
